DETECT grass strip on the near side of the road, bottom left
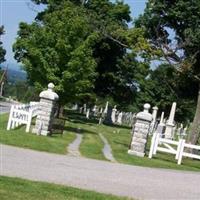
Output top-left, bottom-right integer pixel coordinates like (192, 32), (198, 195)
(0, 176), (127, 200)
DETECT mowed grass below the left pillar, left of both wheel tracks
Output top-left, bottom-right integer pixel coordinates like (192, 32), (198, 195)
(0, 114), (76, 154)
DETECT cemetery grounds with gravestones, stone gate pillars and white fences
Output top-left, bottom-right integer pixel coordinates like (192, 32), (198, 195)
(1, 84), (200, 171)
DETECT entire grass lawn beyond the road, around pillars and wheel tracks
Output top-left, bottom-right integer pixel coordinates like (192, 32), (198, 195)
(0, 111), (200, 171)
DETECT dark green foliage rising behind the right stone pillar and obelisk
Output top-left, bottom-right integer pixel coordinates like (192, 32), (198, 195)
(137, 64), (198, 122)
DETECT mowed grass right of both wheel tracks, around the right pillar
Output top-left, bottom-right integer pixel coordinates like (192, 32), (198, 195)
(95, 125), (200, 171)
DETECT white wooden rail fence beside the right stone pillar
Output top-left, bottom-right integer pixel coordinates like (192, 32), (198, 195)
(149, 132), (200, 165)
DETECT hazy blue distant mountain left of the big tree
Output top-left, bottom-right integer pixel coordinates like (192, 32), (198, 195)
(0, 63), (27, 83)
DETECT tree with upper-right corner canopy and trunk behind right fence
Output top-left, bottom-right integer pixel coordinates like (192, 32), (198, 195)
(136, 0), (200, 144)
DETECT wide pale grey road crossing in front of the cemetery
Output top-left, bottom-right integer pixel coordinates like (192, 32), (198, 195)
(0, 145), (200, 200)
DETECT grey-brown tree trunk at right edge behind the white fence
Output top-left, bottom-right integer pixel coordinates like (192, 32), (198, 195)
(188, 84), (200, 144)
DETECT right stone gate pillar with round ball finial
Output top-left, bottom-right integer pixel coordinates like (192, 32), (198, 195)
(128, 104), (153, 157)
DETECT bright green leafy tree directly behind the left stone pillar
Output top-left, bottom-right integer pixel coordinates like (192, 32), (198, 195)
(13, 2), (96, 104)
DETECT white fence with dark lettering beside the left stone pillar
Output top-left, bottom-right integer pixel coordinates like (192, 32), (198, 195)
(7, 102), (39, 132)
